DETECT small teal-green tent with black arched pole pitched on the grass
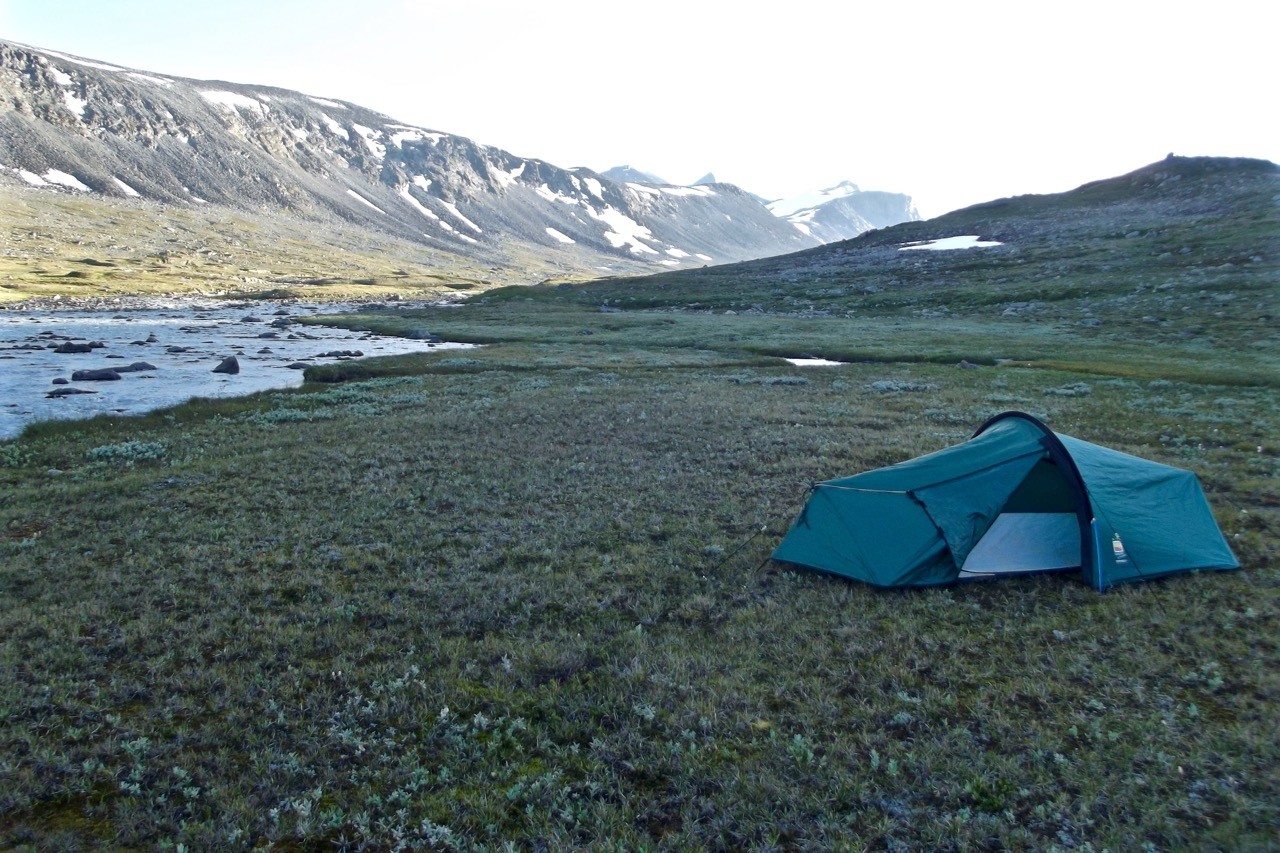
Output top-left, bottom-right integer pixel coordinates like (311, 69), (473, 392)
(773, 411), (1240, 590)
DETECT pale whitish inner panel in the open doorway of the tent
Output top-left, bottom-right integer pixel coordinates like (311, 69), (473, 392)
(960, 512), (1080, 578)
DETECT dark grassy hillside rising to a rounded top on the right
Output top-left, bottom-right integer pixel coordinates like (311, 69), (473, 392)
(547, 158), (1280, 359)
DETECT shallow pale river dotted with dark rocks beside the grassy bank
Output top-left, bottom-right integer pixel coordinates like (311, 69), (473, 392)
(0, 300), (471, 439)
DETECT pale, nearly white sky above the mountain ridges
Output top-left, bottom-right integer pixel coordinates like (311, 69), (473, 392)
(0, 0), (1280, 216)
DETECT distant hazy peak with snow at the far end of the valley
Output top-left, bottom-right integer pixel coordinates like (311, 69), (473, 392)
(768, 181), (920, 243)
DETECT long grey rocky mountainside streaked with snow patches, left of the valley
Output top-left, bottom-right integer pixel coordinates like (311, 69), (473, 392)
(0, 42), (817, 286)
